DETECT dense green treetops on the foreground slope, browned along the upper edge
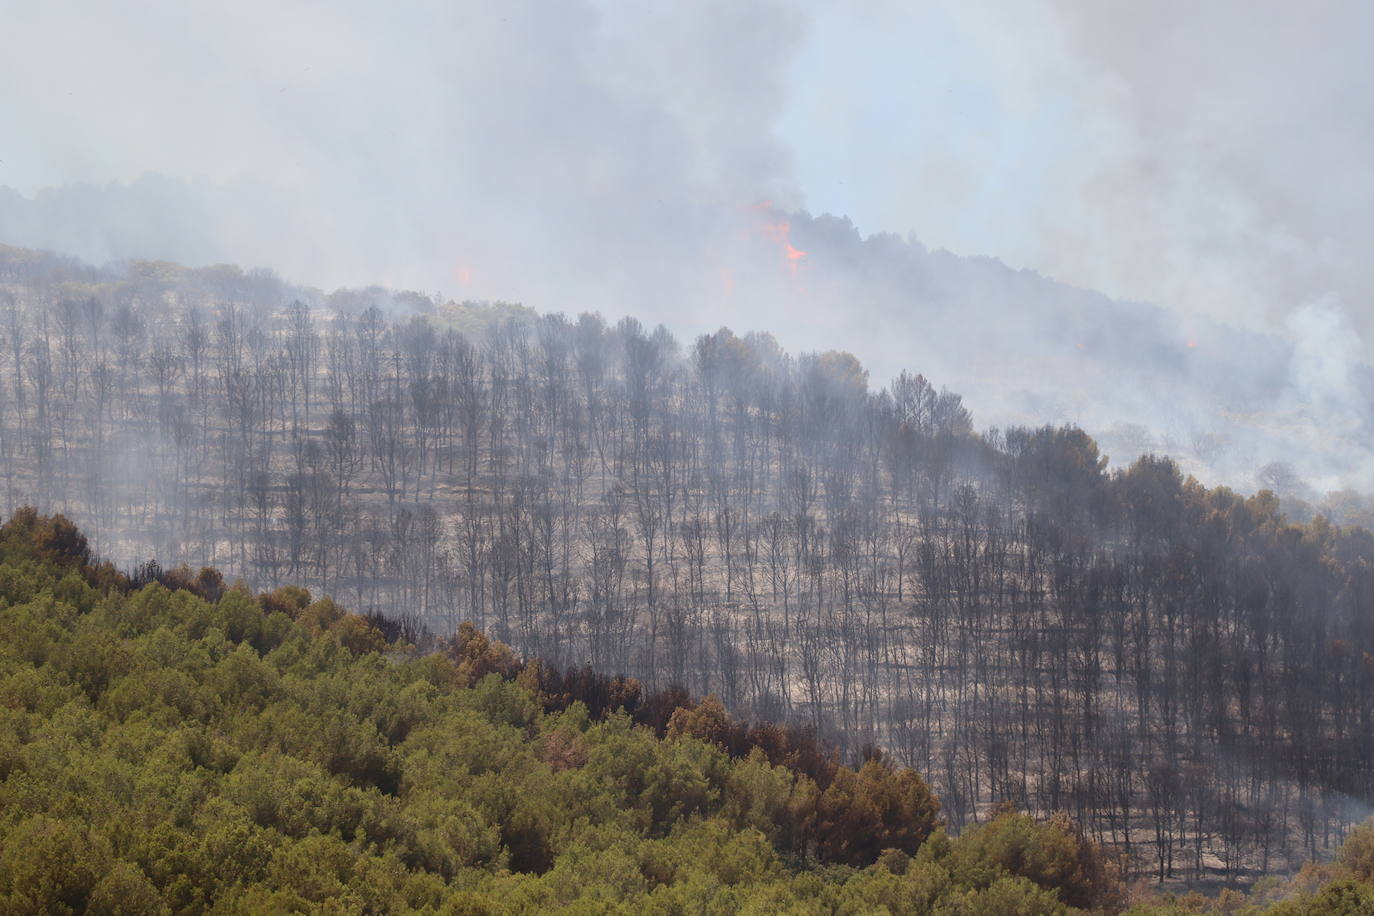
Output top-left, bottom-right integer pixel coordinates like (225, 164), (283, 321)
(8, 511), (1374, 915)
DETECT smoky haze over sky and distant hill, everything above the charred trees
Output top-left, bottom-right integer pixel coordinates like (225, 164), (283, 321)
(0, 3), (1374, 490)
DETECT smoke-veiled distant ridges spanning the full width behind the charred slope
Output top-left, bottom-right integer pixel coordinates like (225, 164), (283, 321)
(0, 176), (1374, 499)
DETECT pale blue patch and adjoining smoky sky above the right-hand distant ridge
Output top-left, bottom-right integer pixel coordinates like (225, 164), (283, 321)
(782, 0), (1374, 338)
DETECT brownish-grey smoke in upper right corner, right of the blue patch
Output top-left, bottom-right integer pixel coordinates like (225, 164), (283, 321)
(1052, 0), (1374, 334)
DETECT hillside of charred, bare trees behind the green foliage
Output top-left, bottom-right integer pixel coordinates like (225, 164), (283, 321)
(0, 250), (1374, 880)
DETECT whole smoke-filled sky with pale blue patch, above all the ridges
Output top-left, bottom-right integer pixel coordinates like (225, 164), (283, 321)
(0, 0), (1374, 346)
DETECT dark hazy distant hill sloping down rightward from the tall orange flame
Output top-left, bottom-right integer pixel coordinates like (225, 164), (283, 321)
(778, 214), (1374, 490)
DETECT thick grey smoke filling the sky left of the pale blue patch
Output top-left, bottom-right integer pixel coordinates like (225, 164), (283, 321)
(0, 0), (802, 310)
